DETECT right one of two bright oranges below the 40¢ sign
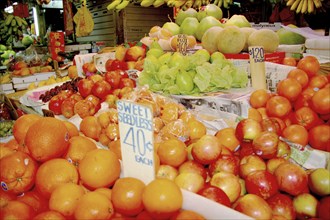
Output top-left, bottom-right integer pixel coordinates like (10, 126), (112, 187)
(142, 179), (183, 218)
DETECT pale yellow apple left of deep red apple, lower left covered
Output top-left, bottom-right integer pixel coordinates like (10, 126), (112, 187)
(210, 171), (241, 203)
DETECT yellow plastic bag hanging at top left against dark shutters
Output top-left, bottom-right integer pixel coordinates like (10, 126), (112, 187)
(73, 1), (94, 37)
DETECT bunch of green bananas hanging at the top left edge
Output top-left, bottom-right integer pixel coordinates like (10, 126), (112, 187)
(0, 14), (28, 45)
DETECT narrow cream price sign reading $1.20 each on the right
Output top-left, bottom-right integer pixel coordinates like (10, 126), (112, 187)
(249, 46), (266, 89)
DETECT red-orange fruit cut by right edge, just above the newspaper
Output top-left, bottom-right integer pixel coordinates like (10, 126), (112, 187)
(308, 124), (330, 152)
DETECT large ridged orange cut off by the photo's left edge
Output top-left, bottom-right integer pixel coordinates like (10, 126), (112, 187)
(0, 151), (38, 194)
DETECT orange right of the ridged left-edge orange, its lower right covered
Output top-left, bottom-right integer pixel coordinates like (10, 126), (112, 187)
(35, 158), (79, 198)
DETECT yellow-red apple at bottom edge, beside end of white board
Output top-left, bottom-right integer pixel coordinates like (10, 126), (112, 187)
(232, 194), (273, 220)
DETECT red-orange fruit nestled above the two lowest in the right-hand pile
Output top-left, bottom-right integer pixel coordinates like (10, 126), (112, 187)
(293, 106), (322, 130)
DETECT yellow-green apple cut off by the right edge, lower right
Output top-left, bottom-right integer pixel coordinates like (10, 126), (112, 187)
(308, 168), (330, 196)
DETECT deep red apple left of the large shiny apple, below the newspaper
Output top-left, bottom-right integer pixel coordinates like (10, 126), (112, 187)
(245, 170), (278, 199)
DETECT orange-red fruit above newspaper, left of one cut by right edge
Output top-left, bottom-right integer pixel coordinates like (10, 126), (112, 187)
(282, 124), (308, 146)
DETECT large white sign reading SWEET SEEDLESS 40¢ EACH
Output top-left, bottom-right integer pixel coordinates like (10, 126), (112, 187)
(117, 100), (155, 184)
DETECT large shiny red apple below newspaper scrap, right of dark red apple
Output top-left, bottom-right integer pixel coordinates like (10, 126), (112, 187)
(274, 162), (308, 196)
